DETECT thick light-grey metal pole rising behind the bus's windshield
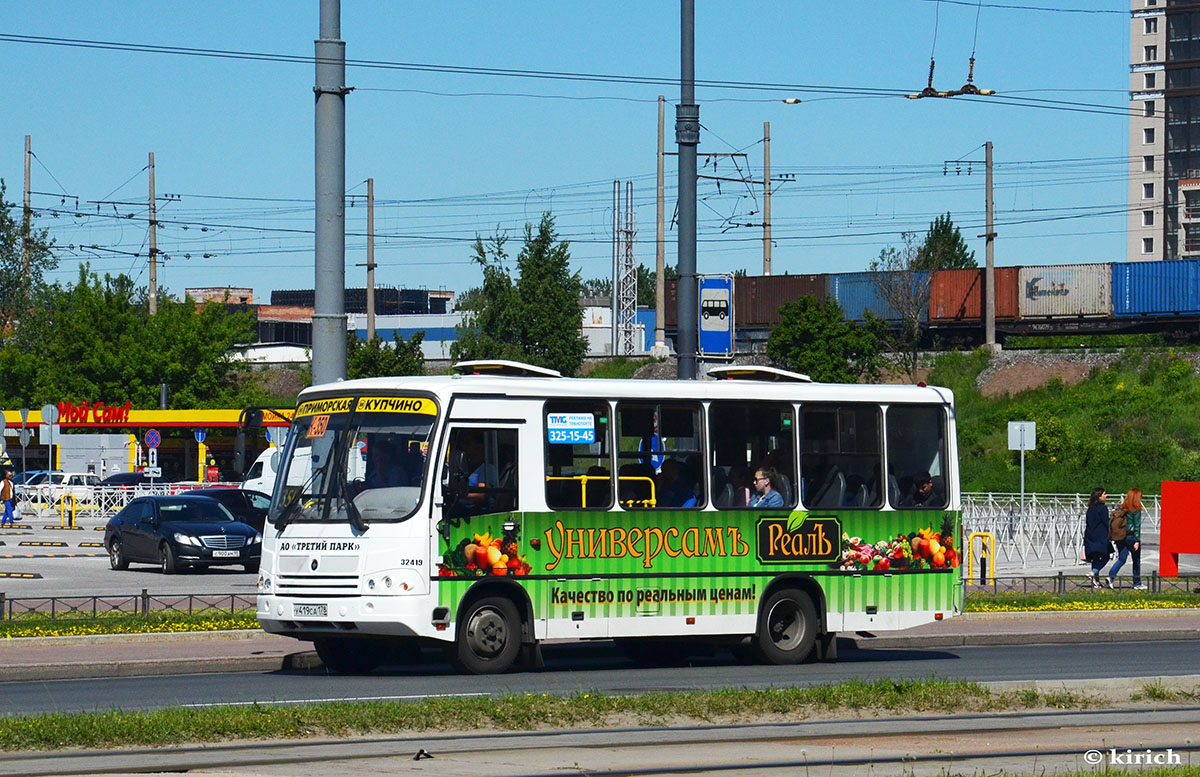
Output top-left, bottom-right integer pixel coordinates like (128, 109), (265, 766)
(312, 0), (349, 384)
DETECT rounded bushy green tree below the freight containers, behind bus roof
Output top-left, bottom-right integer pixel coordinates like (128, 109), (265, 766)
(767, 296), (883, 383)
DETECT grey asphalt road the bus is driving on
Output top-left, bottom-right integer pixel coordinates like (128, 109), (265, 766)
(0, 642), (1200, 715)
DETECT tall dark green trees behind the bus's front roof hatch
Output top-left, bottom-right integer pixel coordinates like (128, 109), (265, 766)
(450, 212), (587, 375)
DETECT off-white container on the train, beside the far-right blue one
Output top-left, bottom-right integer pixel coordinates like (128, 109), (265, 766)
(1016, 263), (1112, 320)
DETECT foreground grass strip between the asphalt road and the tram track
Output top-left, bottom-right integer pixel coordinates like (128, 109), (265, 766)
(0, 679), (1132, 751)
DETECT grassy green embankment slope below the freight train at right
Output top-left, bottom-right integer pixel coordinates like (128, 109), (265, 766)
(926, 348), (1200, 494)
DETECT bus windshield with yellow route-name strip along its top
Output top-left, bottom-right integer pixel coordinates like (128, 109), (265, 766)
(269, 397), (437, 528)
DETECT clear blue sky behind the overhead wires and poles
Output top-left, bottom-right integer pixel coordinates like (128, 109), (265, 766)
(0, 0), (1129, 301)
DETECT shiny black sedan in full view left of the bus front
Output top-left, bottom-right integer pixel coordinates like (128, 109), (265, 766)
(104, 495), (263, 574)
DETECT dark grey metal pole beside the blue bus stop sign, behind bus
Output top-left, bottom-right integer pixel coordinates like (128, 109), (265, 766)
(676, 0), (700, 380)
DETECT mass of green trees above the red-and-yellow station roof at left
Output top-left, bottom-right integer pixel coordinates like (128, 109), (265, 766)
(0, 266), (264, 408)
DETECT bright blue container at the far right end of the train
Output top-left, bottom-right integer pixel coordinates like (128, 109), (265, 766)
(1112, 259), (1200, 315)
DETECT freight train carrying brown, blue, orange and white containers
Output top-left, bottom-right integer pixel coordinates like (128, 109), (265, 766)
(665, 259), (1200, 344)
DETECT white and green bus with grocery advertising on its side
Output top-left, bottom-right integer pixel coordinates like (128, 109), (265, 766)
(258, 362), (962, 673)
